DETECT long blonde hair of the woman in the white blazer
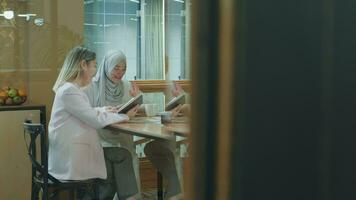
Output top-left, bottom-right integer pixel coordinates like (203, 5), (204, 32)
(53, 46), (96, 92)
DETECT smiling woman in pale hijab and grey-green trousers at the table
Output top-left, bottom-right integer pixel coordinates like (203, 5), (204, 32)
(85, 51), (139, 200)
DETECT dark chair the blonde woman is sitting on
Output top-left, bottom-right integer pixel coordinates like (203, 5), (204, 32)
(23, 123), (99, 200)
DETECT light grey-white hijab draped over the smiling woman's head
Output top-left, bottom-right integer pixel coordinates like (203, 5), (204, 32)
(92, 51), (126, 106)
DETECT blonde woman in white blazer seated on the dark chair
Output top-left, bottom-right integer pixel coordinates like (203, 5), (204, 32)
(48, 46), (136, 199)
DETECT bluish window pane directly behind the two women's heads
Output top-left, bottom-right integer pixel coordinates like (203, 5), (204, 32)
(84, 0), (140, 80)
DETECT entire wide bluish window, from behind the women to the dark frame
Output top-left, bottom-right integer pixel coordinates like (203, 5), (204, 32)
(84, 0), (190, 80)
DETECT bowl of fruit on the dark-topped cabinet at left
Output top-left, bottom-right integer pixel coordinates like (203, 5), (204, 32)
(0, 87), (27, 106)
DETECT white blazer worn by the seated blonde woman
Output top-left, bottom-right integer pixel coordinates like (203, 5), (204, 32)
(48, 82), (129, 180)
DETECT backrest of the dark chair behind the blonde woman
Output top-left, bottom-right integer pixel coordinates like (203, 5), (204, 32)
(23, 123), (60, 184)
